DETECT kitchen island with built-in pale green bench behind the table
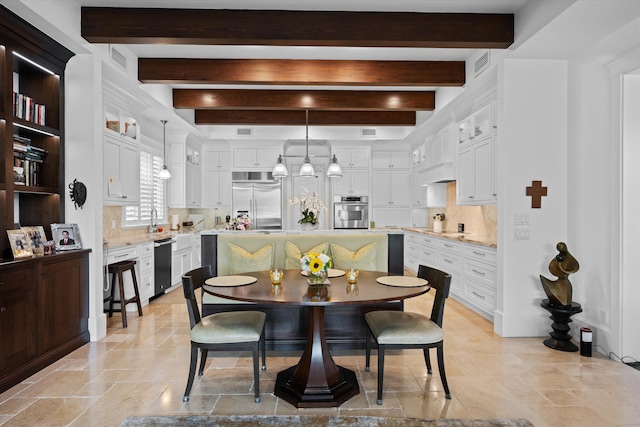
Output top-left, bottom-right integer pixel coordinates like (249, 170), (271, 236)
(200, 229), (404, 350)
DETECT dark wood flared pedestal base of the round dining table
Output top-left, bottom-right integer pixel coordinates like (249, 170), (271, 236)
(274, 306), (360, 408)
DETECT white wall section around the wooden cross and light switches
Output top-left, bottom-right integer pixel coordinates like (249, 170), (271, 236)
(494, 59), (572, 337)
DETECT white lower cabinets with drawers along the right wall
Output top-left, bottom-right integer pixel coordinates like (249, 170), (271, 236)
(404, 231), (497, 320)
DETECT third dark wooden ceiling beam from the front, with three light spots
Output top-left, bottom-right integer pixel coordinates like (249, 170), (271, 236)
(173, 89), (436, 111)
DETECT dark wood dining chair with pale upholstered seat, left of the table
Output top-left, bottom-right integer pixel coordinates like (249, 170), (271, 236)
(182, 265), (267, 403)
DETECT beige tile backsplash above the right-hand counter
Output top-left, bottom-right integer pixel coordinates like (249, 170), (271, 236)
(427, 181), (498, 241)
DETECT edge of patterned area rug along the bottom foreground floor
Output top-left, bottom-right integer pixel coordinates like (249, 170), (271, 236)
(120, 415), (534, 427)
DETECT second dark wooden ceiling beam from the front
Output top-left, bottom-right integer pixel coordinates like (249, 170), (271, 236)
(138, 58), (465, 86)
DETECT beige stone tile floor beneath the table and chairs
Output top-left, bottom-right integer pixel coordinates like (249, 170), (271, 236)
(0, 282), (640, 427)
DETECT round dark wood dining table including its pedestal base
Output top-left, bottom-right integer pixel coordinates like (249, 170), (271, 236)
(203, 270), (429, 408)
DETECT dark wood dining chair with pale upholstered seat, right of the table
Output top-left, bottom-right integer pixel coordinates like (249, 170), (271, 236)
(364, 265), (451, 405)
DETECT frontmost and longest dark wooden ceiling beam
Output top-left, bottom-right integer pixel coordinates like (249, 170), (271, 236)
(81, 7), (514, 49)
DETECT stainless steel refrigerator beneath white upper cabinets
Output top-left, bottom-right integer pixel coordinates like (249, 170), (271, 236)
(231, 172), (282, 230)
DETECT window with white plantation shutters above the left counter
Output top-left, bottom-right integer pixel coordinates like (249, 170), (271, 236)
(124, 149), (166, 226)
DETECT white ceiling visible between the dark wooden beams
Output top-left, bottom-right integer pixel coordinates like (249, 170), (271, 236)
(70, 0), (527, 138)
